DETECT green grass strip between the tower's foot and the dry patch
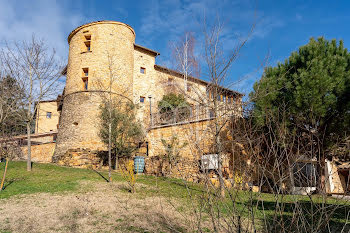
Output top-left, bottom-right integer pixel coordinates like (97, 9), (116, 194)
(0, 161), (199, 199)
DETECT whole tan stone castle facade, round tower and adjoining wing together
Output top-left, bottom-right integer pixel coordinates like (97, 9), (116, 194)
(37, 21), (242, 173)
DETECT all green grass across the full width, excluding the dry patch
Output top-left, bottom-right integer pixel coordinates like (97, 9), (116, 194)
(0, 162), (350, 231)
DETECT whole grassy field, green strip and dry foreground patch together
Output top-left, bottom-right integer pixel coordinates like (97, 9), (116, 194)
(0, 162), (350, 232)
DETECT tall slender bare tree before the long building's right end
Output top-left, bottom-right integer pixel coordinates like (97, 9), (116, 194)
(196, 16), (254, 196)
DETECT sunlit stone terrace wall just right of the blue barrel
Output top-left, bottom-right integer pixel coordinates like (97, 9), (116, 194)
(145, 121), (213, 181)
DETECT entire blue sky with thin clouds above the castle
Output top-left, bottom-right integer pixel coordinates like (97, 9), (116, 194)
(0, 0), (350, 93)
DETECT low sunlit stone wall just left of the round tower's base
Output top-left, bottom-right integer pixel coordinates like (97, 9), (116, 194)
(21, 142), (56, 163)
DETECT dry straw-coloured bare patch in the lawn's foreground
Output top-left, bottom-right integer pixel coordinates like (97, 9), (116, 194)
(0, 182), (186, 232)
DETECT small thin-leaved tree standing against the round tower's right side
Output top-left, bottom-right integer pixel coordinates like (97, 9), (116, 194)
(92, 50), (142, 181)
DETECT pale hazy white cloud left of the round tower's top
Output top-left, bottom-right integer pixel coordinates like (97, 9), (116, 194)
(0, 0), (83, 60)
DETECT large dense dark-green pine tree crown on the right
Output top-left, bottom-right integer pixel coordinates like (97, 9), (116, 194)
(250, 37), (350, 148)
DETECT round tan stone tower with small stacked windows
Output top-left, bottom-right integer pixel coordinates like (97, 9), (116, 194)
(53, 21), (135, 161)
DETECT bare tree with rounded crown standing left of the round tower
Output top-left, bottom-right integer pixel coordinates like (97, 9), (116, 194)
(1, 36), (62, 171)
